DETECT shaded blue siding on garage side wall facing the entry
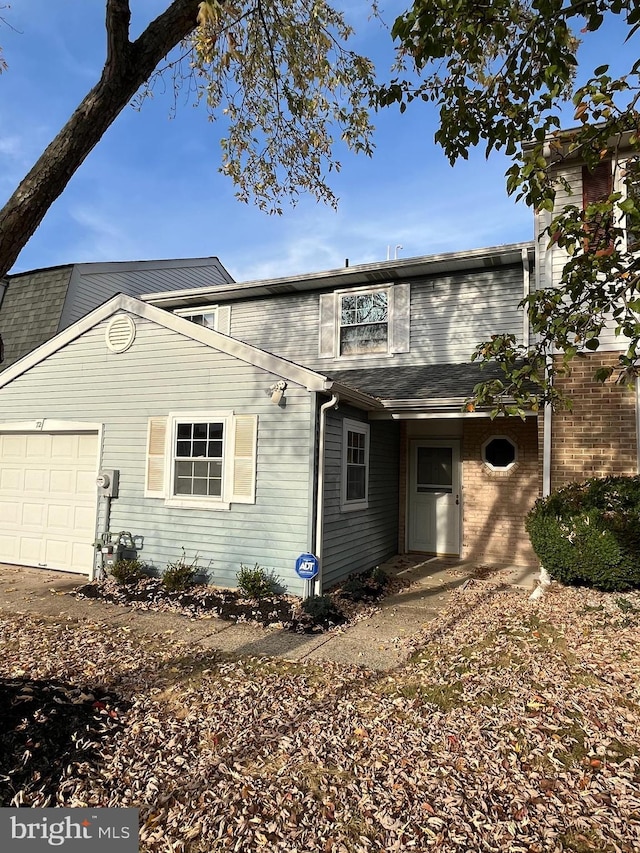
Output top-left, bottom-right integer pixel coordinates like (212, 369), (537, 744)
(323, 406), (400, 589)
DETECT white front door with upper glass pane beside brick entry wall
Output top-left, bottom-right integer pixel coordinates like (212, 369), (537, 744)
(407, 439), (460, 555)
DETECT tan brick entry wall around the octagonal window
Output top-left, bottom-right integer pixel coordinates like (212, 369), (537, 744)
(462, 418), (542, 565)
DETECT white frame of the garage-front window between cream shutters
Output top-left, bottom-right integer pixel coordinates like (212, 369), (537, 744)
(165, 411), (233, 510)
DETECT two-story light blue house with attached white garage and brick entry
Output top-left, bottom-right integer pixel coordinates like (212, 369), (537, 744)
(0, 243), (540, 593)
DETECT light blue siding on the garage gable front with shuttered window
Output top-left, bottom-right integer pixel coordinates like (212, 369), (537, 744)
(0, 318), (314, 594)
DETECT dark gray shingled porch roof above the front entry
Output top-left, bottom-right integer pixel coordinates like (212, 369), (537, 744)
(330, 363), (504, 401)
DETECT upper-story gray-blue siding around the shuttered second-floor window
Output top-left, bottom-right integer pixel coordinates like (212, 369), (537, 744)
(231, 264), (523, 375)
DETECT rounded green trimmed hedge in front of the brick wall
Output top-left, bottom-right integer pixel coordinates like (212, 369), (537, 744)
(525, 477), (640, 592)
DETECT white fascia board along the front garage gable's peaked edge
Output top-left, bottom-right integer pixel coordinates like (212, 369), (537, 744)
(0, 293), (333, 391)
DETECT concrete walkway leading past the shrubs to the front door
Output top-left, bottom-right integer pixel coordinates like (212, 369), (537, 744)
(0, 557), (536, 670)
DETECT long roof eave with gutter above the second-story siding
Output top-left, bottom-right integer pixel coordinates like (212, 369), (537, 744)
(140, 242), (535, 310)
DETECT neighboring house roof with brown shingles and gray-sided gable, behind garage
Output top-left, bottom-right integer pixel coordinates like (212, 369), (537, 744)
(0, 257), (233, 370)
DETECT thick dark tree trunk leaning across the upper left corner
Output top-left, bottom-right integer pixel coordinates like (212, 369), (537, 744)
(0, 0), (199, 279)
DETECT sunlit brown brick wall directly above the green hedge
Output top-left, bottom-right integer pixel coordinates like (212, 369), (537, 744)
(540, 353), (638, 489)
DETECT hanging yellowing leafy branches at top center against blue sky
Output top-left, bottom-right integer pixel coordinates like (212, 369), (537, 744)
(190, 0), (374, 213)
